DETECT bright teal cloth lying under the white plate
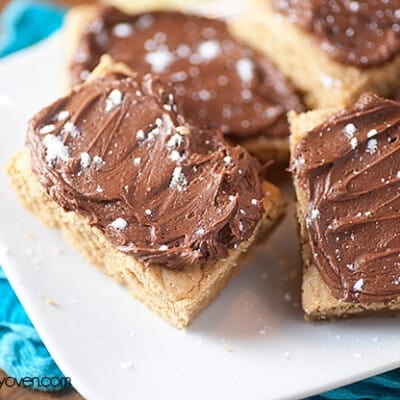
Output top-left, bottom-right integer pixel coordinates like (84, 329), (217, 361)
(0, 0), (400, 400)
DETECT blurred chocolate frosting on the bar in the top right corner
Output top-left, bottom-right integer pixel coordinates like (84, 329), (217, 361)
(269, 0), (400, 68)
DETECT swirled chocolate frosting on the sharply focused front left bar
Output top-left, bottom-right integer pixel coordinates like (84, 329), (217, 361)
(26, 73), (264, 269)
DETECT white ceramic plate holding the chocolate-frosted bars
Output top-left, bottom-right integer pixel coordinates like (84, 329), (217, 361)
(0, 36), (400, 400)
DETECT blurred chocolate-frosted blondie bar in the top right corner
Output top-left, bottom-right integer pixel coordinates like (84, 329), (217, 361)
(230, 0), (400, 108)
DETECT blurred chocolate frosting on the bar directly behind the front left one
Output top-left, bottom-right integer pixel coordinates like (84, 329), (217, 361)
(70, 7), (302, 139)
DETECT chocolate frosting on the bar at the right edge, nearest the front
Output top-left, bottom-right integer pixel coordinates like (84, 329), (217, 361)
(291, 94), (400, 303)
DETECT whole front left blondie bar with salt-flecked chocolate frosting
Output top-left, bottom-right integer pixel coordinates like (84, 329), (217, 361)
(8, 57), (284, 327)
